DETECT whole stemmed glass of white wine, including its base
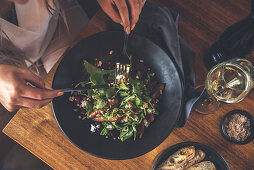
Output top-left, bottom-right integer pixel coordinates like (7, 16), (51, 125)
(194, 58), (254, 114)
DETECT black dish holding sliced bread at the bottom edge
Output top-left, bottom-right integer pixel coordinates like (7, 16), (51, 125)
(153, 142), (230, 170)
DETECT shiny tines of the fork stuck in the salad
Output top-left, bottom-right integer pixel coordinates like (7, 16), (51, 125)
(115, 63), (130, 84)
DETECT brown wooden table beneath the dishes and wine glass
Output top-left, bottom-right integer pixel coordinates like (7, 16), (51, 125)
(3, 0), (254, 170)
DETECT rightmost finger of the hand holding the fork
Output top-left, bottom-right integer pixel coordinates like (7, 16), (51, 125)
(128, 0), (141, 30)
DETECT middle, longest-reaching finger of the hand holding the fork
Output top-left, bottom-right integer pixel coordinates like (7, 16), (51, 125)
(114, 0), (130, 34)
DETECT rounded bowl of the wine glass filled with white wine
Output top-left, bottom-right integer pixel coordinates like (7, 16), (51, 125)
(205, 58), (254, 103)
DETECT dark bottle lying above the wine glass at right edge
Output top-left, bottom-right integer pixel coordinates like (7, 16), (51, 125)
(204, 0), (254, 69)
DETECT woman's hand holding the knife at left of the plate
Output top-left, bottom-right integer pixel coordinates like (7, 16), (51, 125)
(0, 65), (63, 112)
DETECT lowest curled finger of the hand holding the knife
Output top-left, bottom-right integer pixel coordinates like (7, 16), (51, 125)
(19, 97), (52, 109)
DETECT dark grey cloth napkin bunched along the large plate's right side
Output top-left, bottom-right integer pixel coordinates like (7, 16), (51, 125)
(109, 2), (200, 127)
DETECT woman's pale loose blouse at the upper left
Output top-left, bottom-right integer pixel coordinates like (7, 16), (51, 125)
(0, 0), (88, 72)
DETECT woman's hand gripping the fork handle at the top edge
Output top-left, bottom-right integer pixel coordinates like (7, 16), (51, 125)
(97, 0), (146, 34)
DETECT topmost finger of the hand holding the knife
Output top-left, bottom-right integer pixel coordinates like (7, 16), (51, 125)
(20, 69), (45, 88)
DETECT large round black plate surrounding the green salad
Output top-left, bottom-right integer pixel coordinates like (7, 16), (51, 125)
(52, 32), (183, 159)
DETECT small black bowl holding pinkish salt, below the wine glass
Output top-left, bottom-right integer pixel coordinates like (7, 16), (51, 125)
(221, 110), (254, 145)
